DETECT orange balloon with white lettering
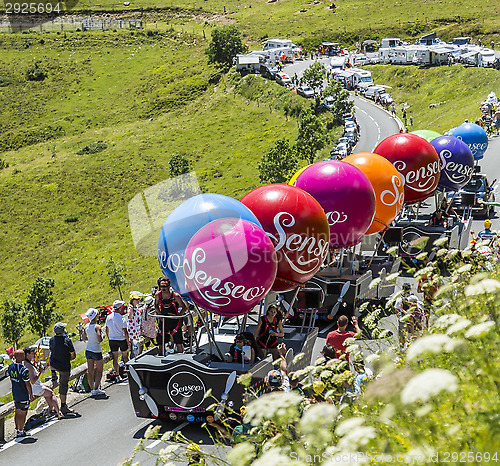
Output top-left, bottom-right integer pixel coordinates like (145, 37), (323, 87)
(342, 152), (404, 235)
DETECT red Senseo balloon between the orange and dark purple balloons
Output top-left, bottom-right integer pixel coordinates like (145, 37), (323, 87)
(373, 133), (441, 204)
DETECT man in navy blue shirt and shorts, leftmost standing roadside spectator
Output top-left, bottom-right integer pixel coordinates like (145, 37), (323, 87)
(7, 350), (35, 438)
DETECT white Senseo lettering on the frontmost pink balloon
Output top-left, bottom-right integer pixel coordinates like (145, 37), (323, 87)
(184, 247), (266, 307)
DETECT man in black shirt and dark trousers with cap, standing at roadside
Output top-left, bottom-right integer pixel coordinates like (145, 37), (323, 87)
(49, 322), (76, 415)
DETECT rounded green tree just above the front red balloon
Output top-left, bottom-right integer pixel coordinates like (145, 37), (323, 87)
(258, 138), (299, 183)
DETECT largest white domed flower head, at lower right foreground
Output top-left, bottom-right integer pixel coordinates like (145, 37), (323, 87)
(401, 369), (458, 404)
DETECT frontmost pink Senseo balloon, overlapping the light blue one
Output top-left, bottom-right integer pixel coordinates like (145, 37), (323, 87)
(184, 218), (278, 316)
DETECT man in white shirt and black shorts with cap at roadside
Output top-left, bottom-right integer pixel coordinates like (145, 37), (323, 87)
(106, 300), (130, 383)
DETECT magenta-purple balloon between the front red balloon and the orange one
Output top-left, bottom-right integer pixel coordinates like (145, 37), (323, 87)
(295, 160), (376, 248)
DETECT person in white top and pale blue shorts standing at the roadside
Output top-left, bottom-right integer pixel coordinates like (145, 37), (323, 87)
(83, 307), (106, 396)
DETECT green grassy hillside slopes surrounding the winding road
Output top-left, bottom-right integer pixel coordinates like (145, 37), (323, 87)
(0, 0), (500, 347)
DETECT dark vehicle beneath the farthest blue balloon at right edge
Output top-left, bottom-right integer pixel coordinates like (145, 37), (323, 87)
(448, 173), (496, 217)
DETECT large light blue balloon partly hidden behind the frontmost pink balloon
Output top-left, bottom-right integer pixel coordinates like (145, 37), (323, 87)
(158, 193), (262, 297)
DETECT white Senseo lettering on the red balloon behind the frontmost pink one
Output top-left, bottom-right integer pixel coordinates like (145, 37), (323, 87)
(267, 212), (328, 274)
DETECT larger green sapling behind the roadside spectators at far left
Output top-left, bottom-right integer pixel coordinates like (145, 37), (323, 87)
(26, 277), (62, 337)
